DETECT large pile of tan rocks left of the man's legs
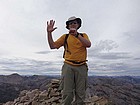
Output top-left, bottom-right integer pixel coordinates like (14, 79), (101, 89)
(3, 79), (61, 105)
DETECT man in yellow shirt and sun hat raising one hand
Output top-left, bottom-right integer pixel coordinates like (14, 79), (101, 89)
(47, 16), (91, 105)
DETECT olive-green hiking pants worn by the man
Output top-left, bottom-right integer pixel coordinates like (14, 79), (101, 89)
(61, 63), (88, 105)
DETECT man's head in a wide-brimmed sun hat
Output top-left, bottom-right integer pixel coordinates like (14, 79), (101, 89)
(66, 16), (82, 29)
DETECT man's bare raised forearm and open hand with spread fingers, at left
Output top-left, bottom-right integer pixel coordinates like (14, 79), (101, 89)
(46, 20), (57, 49)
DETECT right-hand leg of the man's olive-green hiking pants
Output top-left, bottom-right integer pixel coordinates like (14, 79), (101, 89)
(74, 65), (88, 105)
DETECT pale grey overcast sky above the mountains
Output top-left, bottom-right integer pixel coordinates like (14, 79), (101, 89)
(0, 0), (140, 76)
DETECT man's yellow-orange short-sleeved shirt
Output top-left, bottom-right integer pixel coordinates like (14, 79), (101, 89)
(55, 33), (89, 65)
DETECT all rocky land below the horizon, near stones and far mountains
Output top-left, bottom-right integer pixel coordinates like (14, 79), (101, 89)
(0, 74), (140, 105)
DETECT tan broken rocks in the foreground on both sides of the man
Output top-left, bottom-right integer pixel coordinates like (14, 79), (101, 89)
(3, 79), (108, 105)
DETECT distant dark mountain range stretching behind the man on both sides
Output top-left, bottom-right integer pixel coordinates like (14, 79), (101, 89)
(0, 74), (140, 105)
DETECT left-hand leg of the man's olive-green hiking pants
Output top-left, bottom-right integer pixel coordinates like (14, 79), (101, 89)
(61, 63), (75, 105)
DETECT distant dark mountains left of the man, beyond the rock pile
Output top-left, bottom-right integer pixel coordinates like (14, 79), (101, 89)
(0, 74), (52, 103)
